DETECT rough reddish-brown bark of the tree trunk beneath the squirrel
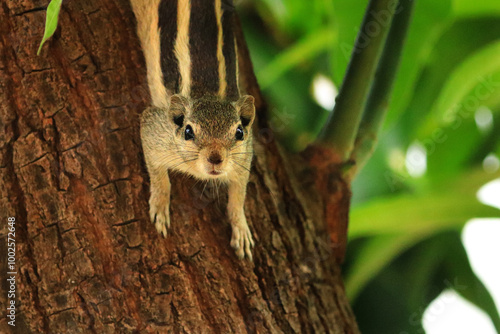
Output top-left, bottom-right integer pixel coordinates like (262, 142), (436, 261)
(0, 0), (358, 333)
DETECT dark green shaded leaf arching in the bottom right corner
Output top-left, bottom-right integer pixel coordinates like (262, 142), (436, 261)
(354, 231), (499, 334)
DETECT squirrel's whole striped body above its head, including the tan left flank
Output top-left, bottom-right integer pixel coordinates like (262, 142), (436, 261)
(130, 0), (239, 108)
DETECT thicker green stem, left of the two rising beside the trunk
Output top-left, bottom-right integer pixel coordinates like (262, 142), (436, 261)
(318, 0), (397, 161)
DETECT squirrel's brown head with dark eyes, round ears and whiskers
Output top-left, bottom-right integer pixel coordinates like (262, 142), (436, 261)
(162, 95), (255, 179)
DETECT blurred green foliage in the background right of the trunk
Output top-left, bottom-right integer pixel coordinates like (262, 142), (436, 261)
(239, 0), (500, 333)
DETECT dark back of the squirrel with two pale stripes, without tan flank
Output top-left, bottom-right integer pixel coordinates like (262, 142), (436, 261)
(158, 0), (239, 101)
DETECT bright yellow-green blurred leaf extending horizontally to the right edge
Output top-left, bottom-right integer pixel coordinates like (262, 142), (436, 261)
(349, 169), (500, 239)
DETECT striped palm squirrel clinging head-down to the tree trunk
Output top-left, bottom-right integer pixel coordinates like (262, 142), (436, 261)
(131, 0), (255, 260)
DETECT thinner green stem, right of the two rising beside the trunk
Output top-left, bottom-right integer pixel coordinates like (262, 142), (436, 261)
(351, 0), (415, 174)
